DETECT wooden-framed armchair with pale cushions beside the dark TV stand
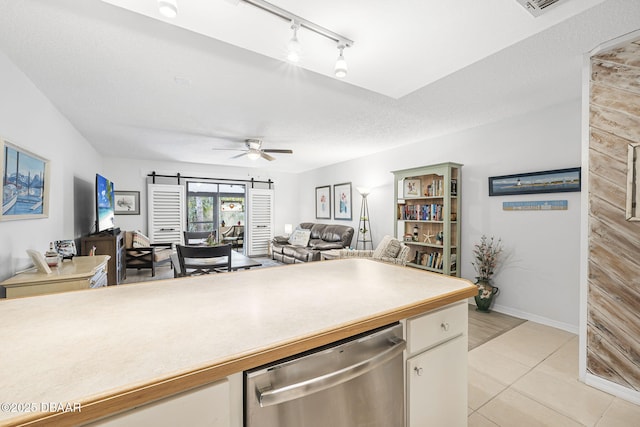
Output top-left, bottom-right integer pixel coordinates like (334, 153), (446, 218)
(124, 231), (173, 277)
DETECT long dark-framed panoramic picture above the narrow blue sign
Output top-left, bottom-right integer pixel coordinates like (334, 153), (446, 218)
(489, 168), (581, 196)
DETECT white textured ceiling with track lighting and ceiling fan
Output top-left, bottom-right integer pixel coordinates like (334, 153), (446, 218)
(0, 0), (640, 172)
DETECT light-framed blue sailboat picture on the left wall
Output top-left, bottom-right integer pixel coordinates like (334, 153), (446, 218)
(0, 140), (49, 221)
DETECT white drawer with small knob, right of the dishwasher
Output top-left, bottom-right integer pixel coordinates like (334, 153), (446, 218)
(407, 302), (468, 354)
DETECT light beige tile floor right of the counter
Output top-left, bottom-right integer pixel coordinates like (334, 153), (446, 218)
(469, 322), (640, 427)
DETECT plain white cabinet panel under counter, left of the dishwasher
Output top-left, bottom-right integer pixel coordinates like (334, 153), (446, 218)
(85, 379), (230, 427)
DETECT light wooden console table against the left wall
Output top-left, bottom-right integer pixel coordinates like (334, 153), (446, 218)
(0, 255), (111, 298)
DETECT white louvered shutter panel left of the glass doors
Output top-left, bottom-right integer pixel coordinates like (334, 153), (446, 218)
(147, 184), (186, 245)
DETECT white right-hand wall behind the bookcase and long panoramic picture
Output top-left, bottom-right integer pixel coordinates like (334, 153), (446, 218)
(299, 100), (581, 332)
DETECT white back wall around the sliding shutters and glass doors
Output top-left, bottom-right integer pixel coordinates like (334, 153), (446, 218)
(104, 158), (299, 235)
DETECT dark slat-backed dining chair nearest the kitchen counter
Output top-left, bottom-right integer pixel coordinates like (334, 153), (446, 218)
(176, 245), (231, 276)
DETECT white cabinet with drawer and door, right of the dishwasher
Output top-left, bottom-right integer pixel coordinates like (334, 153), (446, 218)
(406, 302), (468, 427)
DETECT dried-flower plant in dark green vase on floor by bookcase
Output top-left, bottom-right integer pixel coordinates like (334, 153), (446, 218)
(471, 235), (502, 312)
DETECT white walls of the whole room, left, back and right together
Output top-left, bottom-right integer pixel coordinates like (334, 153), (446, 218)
(0, 43), (581, 332)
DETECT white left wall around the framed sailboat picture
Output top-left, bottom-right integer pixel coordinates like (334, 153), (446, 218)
(0, 53), (101, 280)
